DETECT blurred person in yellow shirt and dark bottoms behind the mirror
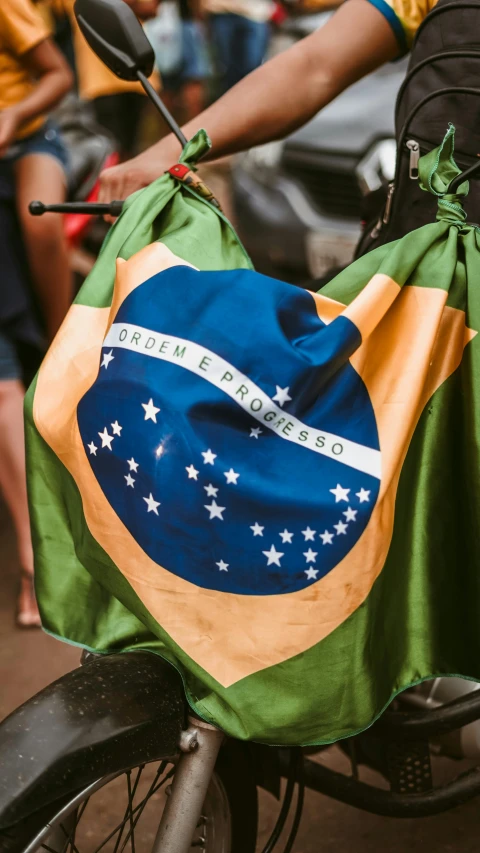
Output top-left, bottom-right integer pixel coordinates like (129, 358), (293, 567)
(49, 0), (159, 159)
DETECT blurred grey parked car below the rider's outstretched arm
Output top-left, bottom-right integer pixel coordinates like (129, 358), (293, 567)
(233, 12), (406, 283)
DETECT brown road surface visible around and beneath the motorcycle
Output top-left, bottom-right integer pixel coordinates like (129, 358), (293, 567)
(0, 502), (480, 853)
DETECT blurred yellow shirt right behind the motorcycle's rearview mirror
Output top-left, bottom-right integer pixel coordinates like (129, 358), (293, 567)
(48, 0), (159, 101)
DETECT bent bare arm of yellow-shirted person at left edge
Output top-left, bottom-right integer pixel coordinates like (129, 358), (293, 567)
(0, 39), (73, 157)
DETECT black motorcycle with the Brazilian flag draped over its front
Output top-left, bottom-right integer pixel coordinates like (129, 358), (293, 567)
(0, 0), (480, 853)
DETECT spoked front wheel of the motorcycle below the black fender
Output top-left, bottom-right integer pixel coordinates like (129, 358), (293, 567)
(0, 743), (257, 853)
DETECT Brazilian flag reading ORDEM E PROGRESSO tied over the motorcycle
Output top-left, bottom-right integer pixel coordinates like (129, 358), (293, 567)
(26, 127), (480, 744)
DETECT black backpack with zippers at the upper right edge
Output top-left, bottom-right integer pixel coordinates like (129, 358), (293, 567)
(356, 0), (480, 257)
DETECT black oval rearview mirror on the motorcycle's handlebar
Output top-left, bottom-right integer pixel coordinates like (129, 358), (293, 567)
(74, 0), (155, 81)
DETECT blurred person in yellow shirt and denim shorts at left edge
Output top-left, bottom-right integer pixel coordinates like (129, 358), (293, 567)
(0, 0), (73, 339)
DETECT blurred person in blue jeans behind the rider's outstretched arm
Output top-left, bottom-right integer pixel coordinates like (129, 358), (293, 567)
(203, 0), (277, 94)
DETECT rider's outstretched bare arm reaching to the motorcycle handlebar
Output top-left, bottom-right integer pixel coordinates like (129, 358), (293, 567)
(99, 0), (399, 202)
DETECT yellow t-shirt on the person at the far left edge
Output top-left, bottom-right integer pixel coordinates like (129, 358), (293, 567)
(0, 0), (50, 139)
